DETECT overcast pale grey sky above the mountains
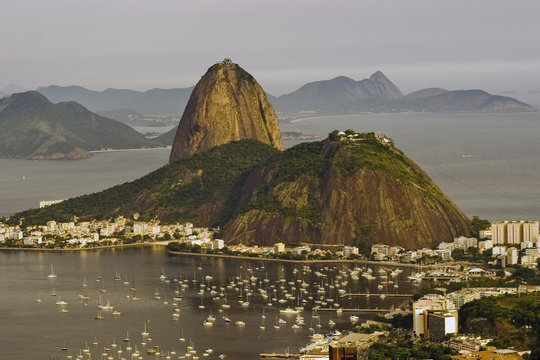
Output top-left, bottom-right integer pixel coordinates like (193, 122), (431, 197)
(0, 0), (540, 95)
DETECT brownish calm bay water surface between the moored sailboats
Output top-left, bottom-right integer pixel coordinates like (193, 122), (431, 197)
(0, 247), (413, 359)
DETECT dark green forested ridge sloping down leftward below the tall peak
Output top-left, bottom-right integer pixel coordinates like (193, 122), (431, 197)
(9, 140), (277, 225)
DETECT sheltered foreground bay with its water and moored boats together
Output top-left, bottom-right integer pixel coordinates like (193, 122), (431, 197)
(0, 246), (416, 359)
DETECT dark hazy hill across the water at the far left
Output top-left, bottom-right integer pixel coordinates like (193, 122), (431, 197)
(0, 91), (159, 159)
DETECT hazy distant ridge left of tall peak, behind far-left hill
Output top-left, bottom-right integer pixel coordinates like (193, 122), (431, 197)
(37, 85), (193, 115)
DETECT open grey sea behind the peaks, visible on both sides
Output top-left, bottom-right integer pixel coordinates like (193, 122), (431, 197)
(0, 112), (540, 220)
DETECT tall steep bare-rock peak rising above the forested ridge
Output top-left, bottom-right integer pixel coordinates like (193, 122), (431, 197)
(170, 59), (283, 162)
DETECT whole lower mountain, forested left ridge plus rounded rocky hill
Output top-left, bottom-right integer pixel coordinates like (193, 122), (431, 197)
(10, 132), (470, 248)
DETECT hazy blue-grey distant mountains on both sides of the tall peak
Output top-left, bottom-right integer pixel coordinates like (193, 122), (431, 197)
(31, 71), (534, 121)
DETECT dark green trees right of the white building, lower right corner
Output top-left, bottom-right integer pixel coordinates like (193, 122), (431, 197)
(459, 294), (540, 352)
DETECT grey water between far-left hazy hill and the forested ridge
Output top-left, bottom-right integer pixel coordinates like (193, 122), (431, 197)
(0, 149), (170, 216)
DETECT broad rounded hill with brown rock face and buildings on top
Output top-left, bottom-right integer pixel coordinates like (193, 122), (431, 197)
(224, 134), (470, 248)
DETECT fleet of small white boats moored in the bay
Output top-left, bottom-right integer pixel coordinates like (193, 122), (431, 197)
(42, 263), (414, 360)
